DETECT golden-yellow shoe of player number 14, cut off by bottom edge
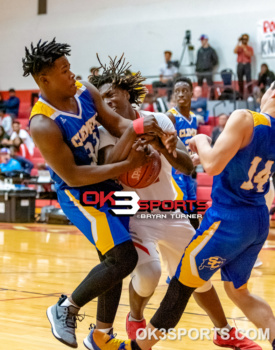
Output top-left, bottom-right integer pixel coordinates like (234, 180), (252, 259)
(87, 329), (132, 350)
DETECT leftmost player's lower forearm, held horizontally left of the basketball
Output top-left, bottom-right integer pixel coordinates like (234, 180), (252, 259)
(64, 160), (133, 187)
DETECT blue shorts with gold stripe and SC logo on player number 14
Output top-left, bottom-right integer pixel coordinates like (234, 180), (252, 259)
(176, 206), (269, 288)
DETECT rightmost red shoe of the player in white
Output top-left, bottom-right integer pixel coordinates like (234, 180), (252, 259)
(213, 327), (262, 350)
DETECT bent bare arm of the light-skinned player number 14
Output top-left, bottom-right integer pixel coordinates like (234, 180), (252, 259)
(187, 110), (254, 176)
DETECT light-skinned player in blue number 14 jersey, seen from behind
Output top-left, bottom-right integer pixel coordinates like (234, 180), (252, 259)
(90, 82), (275, 350)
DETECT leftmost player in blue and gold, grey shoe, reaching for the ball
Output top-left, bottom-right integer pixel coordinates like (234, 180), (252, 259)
(23, 39), (176, 348)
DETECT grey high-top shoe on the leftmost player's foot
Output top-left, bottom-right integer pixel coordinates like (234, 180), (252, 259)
(47, 295), (84, 348)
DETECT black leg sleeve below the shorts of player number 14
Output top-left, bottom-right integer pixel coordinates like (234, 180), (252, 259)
(151, 277), (195, 332)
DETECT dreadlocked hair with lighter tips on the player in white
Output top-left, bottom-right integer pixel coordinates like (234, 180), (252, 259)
(88, 54), (148, 105)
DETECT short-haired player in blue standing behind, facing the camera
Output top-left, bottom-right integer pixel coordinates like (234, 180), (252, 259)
(166, 77), (199, 229)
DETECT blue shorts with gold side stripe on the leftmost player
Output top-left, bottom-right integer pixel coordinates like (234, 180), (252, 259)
(57, 188), (131, 255)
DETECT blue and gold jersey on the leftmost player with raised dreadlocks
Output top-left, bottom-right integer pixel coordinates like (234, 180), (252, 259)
(30, 82), (119, 190)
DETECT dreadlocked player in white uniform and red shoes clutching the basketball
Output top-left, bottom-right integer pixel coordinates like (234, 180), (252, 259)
(84, 57), (261, 350)
